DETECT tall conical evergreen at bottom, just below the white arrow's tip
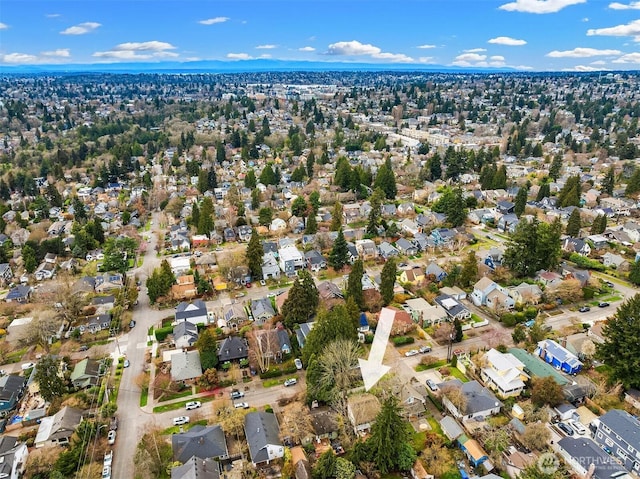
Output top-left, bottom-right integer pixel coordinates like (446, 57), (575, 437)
(366, 396), (416, 475)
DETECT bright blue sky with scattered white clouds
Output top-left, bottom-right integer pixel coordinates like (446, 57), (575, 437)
(0, 0), (640, 71)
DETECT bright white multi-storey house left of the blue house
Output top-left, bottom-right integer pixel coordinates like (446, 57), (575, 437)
(480, 348), (529, 399)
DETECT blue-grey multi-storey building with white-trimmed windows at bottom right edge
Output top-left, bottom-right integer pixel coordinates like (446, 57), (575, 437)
(592, 409), (640, 476)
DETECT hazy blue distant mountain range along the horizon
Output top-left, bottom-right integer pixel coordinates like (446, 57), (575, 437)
(0, 59), (517, 74)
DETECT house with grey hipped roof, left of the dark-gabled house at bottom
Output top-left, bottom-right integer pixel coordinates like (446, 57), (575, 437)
(171, 424), (229, 463)
